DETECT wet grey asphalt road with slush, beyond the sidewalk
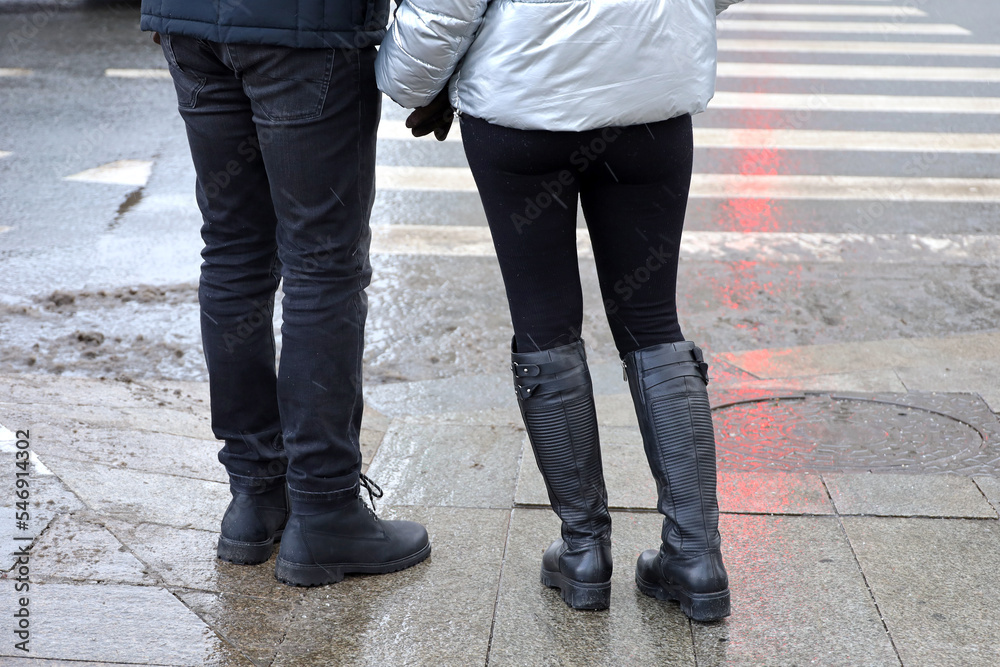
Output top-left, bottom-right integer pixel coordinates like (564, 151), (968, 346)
(0, 0), (1000, 383)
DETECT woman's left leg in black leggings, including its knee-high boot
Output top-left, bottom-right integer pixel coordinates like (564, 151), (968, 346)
(462, 117), (612, 609)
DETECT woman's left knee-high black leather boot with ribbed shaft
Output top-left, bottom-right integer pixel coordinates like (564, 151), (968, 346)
(511, 341), (611, 609)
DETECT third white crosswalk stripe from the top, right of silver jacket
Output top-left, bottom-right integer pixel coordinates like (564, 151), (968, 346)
(718, 38), (1000, 57)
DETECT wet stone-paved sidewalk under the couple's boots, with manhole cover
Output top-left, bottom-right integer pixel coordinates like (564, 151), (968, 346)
(0, 333), (1000, 667)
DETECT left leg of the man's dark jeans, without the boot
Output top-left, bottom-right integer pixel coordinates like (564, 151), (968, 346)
(163, 35), (285, 485)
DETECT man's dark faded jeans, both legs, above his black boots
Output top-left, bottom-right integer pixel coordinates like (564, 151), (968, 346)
(162, 35), (381, 506)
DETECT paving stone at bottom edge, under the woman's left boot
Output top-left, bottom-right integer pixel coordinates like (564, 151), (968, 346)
(487, 509), (695, 667)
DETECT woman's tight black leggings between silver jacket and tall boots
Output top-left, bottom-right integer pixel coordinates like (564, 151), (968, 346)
(462, 115), (693, 357)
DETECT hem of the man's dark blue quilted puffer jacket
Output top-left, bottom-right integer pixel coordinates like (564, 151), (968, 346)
(140, 0), (389, 49)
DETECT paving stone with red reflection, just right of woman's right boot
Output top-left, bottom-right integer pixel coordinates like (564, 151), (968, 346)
(692, 514), (899, 667)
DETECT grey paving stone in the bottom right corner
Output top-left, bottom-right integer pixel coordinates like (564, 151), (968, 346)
(843, 517), (1000, 667)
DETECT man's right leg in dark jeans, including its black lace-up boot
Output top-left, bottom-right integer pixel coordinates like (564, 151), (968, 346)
(224, 45), (430, 586)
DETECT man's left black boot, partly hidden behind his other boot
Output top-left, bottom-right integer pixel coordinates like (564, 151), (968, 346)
(216, 476), (288, 565)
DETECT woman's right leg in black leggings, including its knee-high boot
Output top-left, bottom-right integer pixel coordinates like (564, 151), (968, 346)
(581, 116), (729, 621)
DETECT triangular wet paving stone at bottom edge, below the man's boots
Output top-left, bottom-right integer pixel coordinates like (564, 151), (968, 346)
(175, 591), (294, 665)
